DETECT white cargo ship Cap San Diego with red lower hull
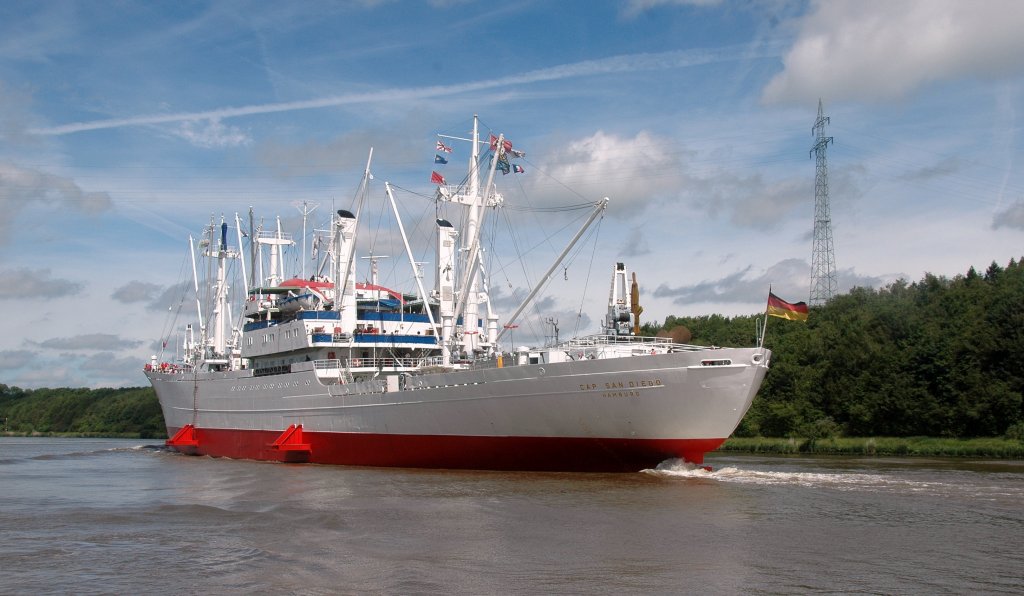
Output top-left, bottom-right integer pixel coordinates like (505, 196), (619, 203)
(144, 117), (771, 471)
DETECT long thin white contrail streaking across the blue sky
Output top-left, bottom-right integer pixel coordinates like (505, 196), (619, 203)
(29, 46), (777, 135)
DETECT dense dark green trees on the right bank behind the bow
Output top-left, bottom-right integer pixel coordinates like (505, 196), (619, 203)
(642, 259), (1024, 438)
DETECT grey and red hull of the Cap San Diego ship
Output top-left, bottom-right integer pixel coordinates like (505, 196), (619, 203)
(148, 348), (770, 472)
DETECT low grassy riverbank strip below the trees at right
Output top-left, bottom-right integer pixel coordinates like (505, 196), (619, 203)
(718, 436), (1024, 460)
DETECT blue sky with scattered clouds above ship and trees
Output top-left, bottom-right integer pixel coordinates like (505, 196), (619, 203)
(0, 0), (1024, 388)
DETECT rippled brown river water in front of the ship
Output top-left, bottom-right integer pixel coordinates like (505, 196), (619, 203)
(0, 438), (1024, 594)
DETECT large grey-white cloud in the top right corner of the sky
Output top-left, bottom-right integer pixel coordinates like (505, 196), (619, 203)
(762, 0), (1024, 103)
